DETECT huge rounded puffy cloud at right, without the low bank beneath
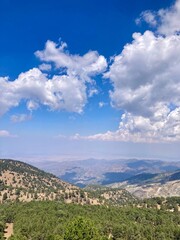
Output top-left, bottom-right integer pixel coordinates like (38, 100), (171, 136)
(105, 31), (180, 118)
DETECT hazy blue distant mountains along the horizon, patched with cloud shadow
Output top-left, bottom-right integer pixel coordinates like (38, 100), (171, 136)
(31, 159), (180, 187)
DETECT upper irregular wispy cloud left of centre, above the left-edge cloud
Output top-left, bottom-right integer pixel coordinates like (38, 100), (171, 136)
(35, 41), (107, 81)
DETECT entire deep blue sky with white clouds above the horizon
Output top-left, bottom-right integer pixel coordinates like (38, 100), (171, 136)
(0, 0), (180, 161)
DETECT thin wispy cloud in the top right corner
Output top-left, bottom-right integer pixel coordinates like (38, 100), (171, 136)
(136, 0), (180, 35)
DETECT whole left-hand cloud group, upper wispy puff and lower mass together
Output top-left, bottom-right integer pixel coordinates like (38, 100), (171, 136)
(0, 41), (107, 116)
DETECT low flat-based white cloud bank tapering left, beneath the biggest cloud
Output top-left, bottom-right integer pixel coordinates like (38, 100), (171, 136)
(84, 108), (180, 142)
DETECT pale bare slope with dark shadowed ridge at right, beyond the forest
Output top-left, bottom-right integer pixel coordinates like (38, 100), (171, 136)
(110, 170), (180, 198)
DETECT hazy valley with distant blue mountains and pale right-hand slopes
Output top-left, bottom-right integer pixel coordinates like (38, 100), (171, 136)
(31, 159), (180, 198)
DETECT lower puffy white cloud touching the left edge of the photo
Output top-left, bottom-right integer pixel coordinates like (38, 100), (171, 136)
(0, 68), (87, 115)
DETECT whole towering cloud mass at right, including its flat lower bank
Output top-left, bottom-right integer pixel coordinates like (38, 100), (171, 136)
(100, 31), (180, 142)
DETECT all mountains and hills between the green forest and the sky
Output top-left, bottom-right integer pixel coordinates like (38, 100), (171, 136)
(0, 159), (180, 202)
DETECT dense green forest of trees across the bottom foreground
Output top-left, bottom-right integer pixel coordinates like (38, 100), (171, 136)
(0, 201), (180, 240)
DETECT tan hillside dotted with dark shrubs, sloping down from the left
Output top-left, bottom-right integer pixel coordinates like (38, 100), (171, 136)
(0, 159), (135, 205)
